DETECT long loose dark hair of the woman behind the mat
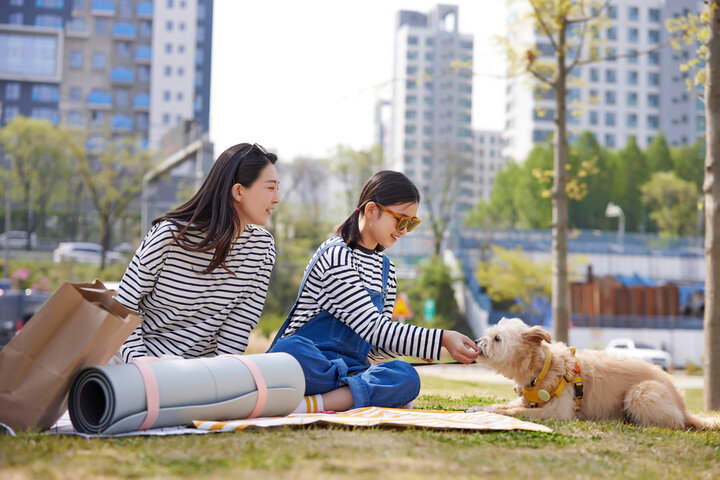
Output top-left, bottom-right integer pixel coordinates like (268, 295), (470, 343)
(152, 143), (277, 273)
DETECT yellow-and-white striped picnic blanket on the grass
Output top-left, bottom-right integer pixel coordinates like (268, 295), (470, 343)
(191, 407), (552, 433)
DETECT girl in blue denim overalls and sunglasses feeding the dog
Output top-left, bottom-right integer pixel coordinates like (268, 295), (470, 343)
(269, 171), (478, 412)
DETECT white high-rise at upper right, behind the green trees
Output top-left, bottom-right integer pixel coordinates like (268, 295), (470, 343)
(503, 0), (705, 161)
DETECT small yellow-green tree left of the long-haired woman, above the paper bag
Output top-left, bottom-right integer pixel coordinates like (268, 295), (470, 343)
(72, 132), (154, 270)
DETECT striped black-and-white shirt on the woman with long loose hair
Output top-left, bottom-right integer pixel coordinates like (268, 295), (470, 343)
(116, 222), (275, 362)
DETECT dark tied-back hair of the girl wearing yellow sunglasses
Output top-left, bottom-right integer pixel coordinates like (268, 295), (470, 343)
(335, 170), (420, 252)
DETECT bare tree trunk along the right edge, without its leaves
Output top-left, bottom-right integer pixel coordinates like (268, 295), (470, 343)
(703, 0), (720, 410)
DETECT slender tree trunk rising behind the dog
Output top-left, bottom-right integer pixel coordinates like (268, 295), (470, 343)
(551, 24), (569, 343)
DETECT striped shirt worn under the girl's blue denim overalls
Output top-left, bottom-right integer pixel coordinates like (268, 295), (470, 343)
(283, 237), (442, 360)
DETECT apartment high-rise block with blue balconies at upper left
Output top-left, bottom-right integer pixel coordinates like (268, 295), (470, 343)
(0, 0), (213, 146)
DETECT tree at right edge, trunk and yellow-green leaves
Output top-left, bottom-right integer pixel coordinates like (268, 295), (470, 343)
(666, 0), (720, 410)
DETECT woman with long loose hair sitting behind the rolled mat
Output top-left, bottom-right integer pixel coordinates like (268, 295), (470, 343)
(116, 143), (280, 362)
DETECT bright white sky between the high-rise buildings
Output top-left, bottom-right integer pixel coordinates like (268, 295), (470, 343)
(210, 0), (505, 161)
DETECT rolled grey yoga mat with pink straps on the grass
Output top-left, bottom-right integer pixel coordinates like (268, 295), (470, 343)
(68, 352), (305, 435)
